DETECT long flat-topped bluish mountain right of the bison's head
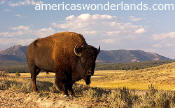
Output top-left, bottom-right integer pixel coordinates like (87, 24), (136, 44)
(97, 50), (171, 63)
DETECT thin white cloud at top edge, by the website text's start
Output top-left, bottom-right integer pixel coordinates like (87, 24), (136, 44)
(8, 0), (43, 7)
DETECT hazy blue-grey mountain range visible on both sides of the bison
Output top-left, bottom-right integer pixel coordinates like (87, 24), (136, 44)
(0, 45), (171, 64)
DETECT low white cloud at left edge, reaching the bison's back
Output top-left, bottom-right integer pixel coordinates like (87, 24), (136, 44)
(0, 25), (55, 47)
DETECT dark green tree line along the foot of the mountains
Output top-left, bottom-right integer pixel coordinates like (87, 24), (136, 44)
(0, 61), (173, 73)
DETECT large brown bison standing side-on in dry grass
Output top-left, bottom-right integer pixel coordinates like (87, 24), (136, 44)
(26, 32), (100, 96)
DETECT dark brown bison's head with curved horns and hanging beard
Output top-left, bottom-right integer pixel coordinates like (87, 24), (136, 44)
(74, 45), (100, 85)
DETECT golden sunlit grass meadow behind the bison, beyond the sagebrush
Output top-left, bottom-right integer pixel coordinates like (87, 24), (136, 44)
(5, 63), (175, 91)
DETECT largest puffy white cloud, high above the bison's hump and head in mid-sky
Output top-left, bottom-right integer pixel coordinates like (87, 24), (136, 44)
(52, 14), (145, 40)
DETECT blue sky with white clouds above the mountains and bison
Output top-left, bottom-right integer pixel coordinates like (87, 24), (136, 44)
(0, 0), (175, 58)
